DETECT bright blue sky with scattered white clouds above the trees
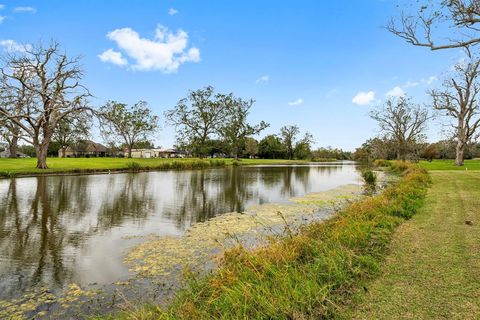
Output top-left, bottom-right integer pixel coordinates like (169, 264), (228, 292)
(0, 0), (461, 150)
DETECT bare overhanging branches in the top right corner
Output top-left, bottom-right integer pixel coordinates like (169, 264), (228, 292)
(387, 0), (480, 50)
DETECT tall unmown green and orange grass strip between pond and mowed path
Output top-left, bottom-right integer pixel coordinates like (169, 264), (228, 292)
(109, 163), (429, 319)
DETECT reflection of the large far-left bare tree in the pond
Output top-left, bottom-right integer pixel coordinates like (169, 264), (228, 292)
(0, 177), (82, 300)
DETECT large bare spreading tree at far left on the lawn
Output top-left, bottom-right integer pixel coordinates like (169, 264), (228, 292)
(0, 42), (90, 169)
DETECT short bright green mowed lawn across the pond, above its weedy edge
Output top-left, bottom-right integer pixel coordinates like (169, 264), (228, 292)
(0, 158), (308, 174)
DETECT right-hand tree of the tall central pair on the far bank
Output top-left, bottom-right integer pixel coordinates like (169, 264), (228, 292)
(218, 94), (269, 159)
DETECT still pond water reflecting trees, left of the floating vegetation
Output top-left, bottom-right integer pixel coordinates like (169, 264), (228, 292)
(0, 163), (359, 300)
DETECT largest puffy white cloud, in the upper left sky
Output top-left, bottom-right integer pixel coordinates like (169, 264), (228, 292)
(103, 25), (200, 73)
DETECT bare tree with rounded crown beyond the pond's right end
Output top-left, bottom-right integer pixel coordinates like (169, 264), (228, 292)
(370, 97), (431, 160)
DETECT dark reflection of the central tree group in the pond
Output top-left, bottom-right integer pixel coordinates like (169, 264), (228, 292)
(162, 166), (341, 229)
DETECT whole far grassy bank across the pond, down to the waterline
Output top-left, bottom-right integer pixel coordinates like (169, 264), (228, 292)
(0, 158), (304, 177)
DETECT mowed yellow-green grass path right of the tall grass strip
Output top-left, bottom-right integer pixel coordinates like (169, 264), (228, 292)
(345, 171), (480, 319)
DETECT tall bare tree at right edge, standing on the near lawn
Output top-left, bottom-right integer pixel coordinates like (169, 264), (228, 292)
(430, 56), (480, 166)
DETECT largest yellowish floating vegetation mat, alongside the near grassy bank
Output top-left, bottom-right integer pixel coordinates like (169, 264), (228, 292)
(124, 185), (361, 278)
